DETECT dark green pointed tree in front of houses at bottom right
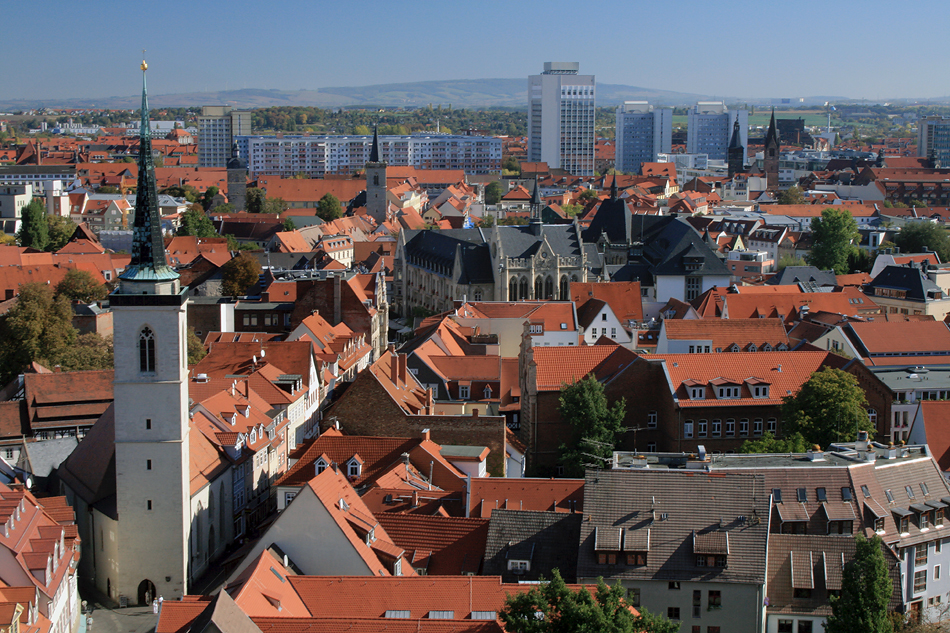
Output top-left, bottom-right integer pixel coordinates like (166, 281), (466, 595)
(825, 532), (894, 633)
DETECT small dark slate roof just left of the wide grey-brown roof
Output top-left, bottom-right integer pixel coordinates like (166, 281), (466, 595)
(482, 509), (584, 582)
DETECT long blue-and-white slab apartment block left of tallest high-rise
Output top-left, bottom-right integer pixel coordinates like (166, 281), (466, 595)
(236, 134), (502, 178)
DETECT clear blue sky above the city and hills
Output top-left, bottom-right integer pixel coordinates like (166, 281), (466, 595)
(7, 0), (950, 100)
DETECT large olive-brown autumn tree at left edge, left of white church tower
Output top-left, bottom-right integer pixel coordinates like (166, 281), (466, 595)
(0, 282), (76, 384)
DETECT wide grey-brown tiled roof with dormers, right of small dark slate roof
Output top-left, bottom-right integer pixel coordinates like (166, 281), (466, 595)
(577, 470), (770, 585)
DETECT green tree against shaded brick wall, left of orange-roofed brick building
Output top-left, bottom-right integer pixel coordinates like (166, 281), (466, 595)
(558, 374), (626, 477)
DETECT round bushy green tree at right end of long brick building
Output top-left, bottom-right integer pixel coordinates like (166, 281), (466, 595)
(782, 367), (877, 447)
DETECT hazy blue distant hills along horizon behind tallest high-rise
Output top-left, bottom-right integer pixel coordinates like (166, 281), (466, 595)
(0, 78), (710, 111)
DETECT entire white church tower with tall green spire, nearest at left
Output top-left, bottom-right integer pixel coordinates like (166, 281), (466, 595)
(110, 61), (191, 603)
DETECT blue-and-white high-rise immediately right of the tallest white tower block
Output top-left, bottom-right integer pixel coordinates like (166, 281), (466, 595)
(614, 101), (673, 174)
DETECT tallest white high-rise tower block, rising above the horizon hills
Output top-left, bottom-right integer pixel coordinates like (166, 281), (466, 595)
(528, 62), (596, 176)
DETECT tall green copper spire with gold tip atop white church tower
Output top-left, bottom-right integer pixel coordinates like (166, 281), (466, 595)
(119, 60), (178, 281)
